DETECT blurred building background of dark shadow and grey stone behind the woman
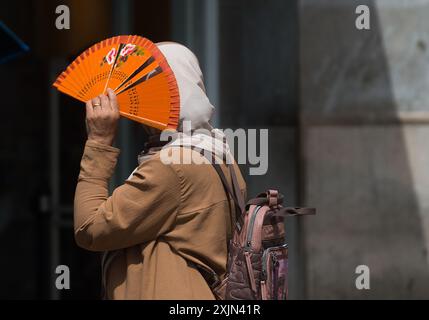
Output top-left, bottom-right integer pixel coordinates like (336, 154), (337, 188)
(0, 0), (429, 299)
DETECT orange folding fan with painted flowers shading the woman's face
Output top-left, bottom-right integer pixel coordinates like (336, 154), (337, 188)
(53, 36), (180, 130)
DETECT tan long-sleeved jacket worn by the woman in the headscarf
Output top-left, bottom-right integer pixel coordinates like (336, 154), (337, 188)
(74, 141), (246, 299)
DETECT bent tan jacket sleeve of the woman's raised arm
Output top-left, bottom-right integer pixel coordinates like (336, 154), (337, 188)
(74, 141), (180, 251)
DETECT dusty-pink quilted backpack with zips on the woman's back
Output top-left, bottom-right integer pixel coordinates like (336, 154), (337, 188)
(200, 163), (316, 300)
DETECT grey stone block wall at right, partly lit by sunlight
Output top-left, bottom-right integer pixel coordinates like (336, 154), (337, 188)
(300, 0), (429, 299)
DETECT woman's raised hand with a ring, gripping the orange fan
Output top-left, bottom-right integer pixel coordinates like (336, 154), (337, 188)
(86, 89), (119, 146)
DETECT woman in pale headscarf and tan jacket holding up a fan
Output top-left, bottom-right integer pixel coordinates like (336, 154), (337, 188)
(74, 43), (245, 299)
